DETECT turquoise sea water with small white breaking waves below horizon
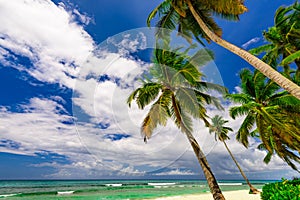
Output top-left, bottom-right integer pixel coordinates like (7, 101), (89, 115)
(0, 180), (270, 200)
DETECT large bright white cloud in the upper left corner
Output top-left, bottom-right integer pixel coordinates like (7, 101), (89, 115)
(0, 0), (94, 87)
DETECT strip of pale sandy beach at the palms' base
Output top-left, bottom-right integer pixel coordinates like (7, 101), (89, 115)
(148, 190), (260, 200)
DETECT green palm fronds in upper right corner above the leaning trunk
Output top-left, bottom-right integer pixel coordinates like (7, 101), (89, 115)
(250, 2), (300, 79)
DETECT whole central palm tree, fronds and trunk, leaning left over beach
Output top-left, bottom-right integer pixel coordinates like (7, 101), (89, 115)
(128, 40), (225, 200)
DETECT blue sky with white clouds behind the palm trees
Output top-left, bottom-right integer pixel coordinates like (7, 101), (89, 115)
(0, 0), (298, 180)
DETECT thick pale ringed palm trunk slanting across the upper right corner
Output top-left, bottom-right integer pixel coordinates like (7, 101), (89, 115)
(186, 0), (300, 99)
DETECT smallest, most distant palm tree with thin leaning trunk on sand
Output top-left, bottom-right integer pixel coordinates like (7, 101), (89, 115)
(209, 115), (260, 194)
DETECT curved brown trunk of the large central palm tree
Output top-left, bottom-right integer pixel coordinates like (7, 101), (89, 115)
(172, 95), (225, 200)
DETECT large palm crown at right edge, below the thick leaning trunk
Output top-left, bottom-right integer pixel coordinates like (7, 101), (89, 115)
(227, 69), (300, 171)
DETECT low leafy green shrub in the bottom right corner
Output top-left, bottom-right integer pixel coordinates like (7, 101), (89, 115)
(261, 178), (300, 200)
